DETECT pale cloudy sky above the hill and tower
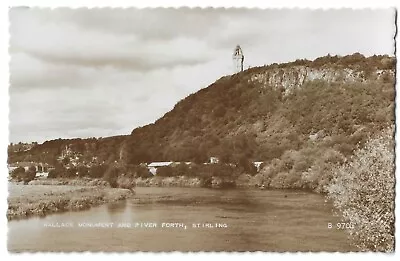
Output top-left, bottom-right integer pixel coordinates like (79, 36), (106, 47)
(9, 8), (395, 142)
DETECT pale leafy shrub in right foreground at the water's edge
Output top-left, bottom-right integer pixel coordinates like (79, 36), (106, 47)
(327, 129), (395, 252)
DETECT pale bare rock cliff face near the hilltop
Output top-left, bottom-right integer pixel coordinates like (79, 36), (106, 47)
(248, 66), (394, 95)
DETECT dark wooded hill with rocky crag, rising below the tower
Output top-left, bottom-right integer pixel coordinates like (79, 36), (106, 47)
(8, 54), (395, 175)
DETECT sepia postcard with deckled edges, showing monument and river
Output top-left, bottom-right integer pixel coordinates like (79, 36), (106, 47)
(7, 6), (396, 253)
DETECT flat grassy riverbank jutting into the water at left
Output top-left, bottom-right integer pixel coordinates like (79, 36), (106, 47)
(7, 183), (133, 220)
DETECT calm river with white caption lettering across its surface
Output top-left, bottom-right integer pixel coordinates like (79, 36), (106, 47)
(7, 187), (357, 252)
